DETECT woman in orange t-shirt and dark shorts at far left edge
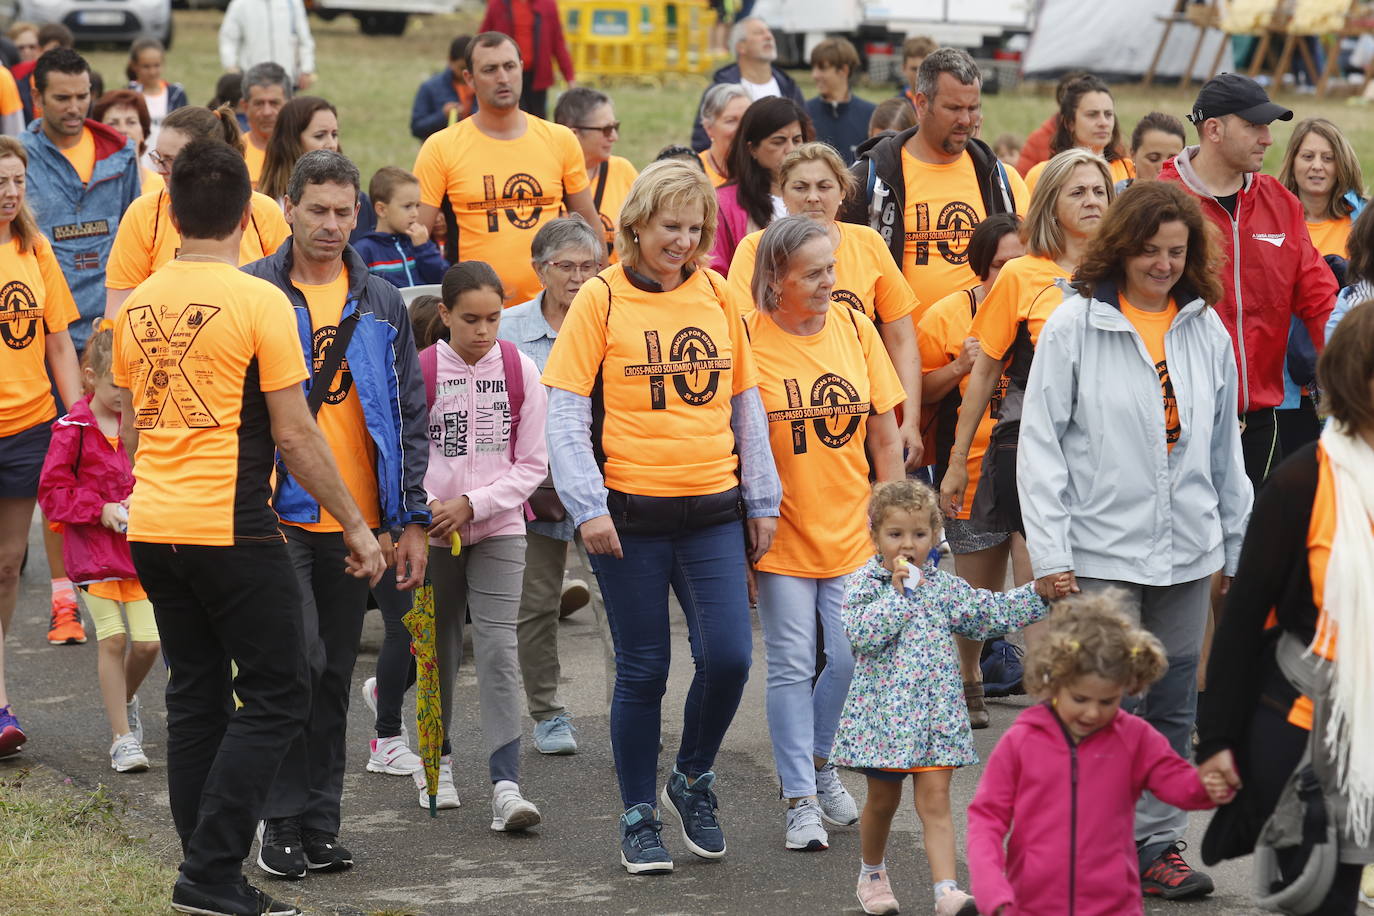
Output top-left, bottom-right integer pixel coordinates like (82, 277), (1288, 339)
(0, 137), (85, 757)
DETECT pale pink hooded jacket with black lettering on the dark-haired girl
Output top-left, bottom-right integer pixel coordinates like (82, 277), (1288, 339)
(425, 342), (548, 547)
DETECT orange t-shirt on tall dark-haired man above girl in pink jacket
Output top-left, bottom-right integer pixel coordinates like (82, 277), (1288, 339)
(415, 114), (588, 305)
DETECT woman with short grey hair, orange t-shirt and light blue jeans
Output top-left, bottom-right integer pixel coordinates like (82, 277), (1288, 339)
(745, 216), (907, 850)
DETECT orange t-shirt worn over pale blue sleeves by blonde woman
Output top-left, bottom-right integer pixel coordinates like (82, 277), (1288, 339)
(543, 264), (758, 496)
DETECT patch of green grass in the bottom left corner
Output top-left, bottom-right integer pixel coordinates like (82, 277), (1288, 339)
(0, 770), (180, 916)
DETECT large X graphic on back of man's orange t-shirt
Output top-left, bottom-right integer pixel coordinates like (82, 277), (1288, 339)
(126, 304), (220, 430)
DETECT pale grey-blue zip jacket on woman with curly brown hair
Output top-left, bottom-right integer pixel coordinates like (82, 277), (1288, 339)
(1017, 284), (1252, 585)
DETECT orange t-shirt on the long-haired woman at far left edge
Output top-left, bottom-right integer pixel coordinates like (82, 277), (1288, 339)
(0, 233), (81, 438)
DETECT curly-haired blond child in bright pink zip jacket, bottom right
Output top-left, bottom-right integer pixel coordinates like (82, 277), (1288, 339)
(969, 592), (1234, 916)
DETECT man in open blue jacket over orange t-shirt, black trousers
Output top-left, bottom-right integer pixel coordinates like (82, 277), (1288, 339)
(245, 150), (430, 878)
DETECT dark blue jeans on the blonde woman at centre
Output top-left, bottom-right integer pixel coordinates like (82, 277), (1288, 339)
(591, 522), (753, 809)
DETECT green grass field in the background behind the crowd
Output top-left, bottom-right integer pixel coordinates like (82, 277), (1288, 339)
(89, 11), (1374, 193)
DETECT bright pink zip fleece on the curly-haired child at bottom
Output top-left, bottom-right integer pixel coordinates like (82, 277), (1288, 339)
(969, 703), (1213, 916)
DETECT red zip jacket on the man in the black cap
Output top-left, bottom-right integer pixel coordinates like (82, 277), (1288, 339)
(1160, 147), (1338, 413)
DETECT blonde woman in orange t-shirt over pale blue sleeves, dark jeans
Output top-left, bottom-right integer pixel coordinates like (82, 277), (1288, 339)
(544, 159), (782, 873)
